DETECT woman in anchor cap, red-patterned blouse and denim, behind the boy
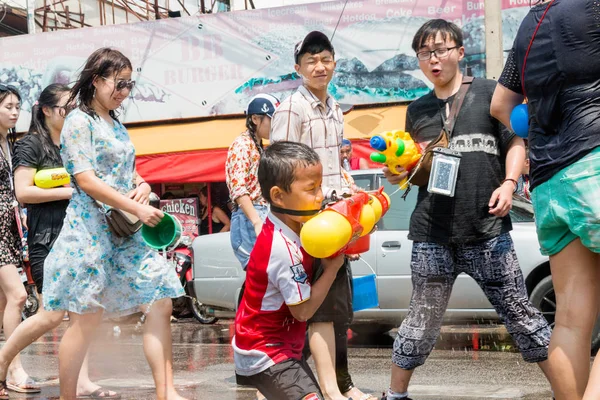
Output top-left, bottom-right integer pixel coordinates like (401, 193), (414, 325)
(225, 94), (279, 269)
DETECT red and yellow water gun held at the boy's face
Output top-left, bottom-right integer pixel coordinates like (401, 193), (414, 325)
(300, 188), (390, 258)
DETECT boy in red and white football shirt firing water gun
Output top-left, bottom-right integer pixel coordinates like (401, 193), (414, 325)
(232, 141), (344, 400)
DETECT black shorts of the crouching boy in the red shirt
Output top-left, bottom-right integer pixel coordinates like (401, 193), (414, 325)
(238, 359), (323, 400)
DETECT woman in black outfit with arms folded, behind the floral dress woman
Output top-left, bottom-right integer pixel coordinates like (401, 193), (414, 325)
(0, 84), (120, 399)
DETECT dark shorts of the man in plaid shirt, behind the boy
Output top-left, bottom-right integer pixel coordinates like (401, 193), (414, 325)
(308, 258), (354, 325)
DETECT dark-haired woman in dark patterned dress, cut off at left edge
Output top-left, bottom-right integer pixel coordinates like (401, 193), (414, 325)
(0, 85), (41, 399)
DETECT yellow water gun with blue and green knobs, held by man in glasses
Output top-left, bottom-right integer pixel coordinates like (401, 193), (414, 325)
(369, 131), (421, 187)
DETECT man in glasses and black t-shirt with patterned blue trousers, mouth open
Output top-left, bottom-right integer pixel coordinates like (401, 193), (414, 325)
(384, 19), (550, 400)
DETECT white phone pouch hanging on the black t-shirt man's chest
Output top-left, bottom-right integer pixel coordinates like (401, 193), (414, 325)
(427, 147), (462, 197)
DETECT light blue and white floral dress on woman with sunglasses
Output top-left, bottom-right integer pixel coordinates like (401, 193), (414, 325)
(43, 110), (184, 314)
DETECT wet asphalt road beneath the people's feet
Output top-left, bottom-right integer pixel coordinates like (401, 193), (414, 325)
(2, 317), (551, 400)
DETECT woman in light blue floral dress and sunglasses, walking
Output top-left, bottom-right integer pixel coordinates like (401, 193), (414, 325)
(11, 48), (184, 400)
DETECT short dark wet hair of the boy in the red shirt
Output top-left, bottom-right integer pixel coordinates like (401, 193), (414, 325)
(258, 141), (321, 203)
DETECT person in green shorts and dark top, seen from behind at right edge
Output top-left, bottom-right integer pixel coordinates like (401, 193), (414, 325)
(491, 0), (600, 400)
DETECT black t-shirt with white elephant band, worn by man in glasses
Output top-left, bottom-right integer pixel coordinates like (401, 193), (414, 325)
(406, 79), (515, 243)
